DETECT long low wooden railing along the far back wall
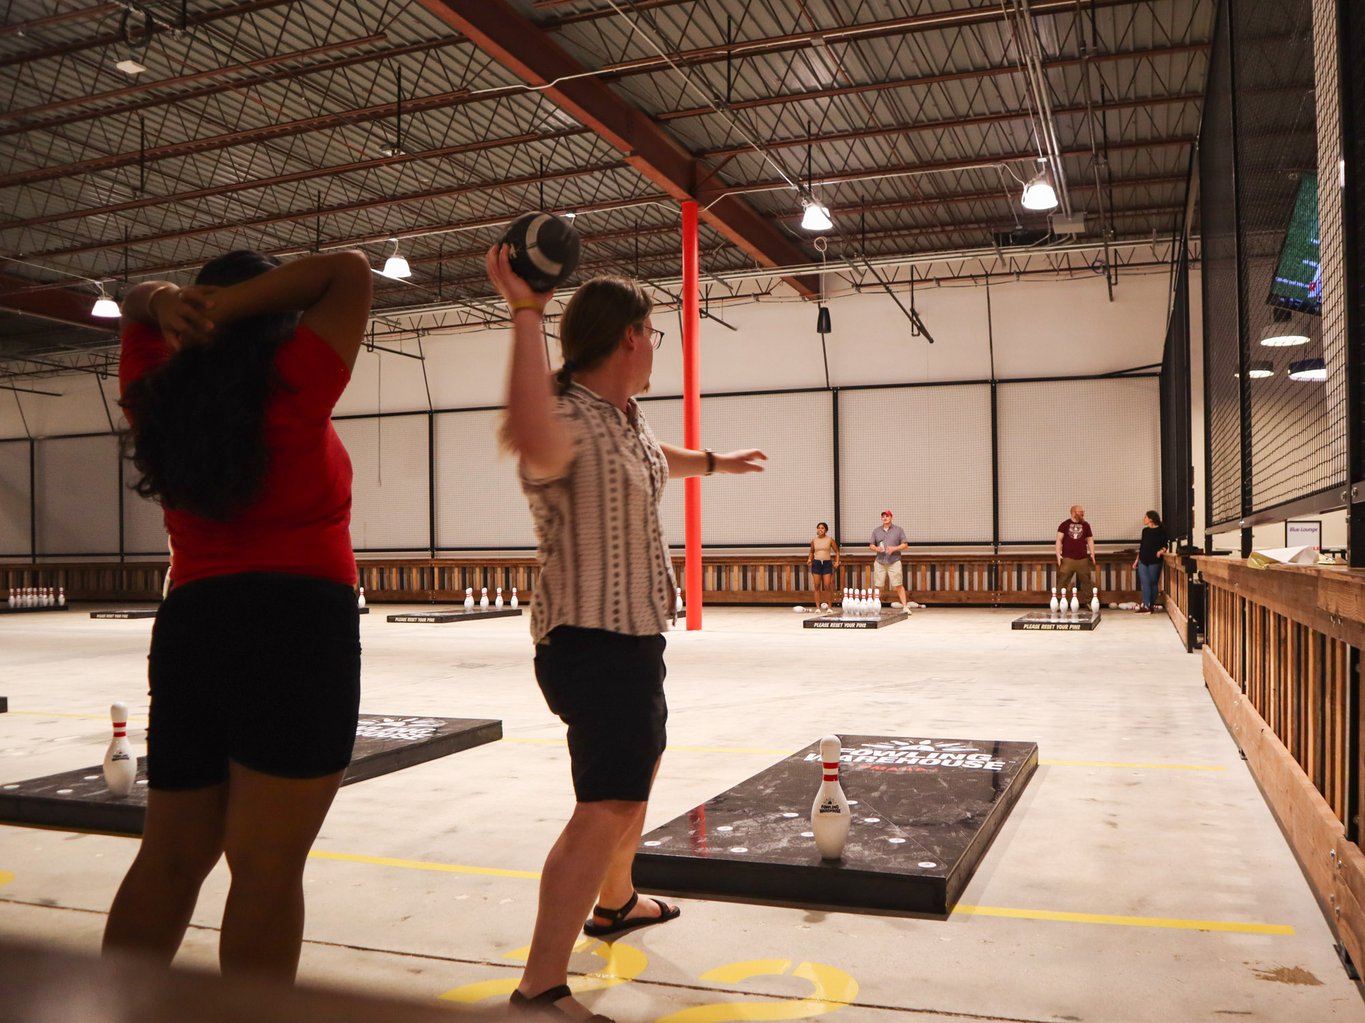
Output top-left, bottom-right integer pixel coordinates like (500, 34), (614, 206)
(0, 552), (1137, 605)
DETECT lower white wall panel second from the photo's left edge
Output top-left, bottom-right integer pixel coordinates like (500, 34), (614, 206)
(37, 434), (119, 555)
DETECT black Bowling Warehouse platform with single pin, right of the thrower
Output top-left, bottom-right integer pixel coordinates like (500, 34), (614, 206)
(635, 735), (1037, 916)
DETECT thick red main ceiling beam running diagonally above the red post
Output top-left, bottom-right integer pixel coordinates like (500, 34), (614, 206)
(420, 0), (819, 296)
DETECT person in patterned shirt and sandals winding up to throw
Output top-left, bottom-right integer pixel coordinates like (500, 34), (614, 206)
(487, 246), (764, 1020)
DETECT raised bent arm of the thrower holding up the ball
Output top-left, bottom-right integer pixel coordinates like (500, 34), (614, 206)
(483, 244), (573, 479)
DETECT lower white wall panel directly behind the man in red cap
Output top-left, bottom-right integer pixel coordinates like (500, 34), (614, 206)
(839, 384), (991, 545)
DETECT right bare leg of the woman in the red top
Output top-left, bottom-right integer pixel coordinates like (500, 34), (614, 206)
(218, 763), (341, 981)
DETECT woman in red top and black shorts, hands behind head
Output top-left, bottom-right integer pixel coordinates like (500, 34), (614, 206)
(104, 251), (370, 981)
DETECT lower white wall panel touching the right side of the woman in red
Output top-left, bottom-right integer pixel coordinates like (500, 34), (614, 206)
(334, 415), (430, 550)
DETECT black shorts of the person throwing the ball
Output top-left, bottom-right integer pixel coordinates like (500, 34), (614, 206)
(535, 626), (669, 803)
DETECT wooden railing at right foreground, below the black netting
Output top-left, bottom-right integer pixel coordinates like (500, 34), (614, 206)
(1197, 557), (1365, 967)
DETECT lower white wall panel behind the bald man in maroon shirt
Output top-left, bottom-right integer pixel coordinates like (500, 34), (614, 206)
(999, 377), (1162, 542)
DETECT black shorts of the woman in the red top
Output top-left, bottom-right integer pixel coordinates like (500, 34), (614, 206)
(147, 572), (360, 789)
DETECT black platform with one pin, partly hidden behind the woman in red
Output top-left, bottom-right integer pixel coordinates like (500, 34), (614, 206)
(0, 714), (502, 835)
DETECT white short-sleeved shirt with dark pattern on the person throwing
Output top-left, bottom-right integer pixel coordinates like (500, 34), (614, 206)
(521, 384), (674, 642)
